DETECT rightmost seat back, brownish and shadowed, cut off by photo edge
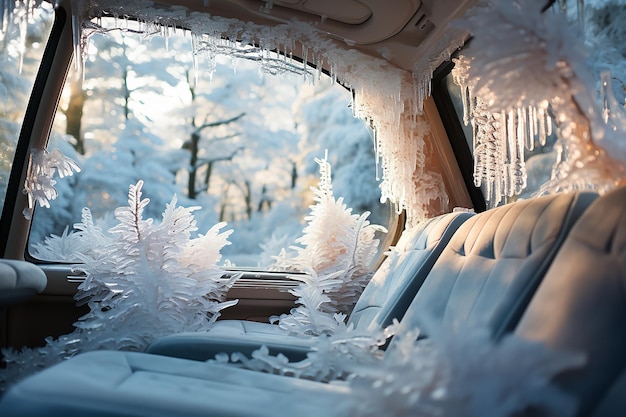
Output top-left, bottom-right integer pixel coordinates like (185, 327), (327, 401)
(515, 187), (626, 416)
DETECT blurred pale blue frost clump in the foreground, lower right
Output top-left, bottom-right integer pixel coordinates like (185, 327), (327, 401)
(350, 322), (584, 417)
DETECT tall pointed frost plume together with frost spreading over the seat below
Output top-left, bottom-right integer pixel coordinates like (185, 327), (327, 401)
(210, 155), (394, 381)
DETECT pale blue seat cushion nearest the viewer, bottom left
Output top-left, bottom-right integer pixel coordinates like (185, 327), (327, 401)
(0, 351), (350, 417)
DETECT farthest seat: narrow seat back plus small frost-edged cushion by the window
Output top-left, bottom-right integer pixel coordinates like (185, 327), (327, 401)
(147, 212), (473, 361)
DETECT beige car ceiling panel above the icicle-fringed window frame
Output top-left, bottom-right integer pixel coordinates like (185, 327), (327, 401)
(130, 0), (475, 70)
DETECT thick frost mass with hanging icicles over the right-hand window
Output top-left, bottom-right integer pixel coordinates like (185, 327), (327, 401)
(452, 1), (626, 206)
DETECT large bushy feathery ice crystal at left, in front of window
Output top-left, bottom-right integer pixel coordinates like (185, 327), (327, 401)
(0, 181), (237, 383)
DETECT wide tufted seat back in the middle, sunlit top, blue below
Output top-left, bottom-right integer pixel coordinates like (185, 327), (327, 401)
(390, 193), (597, 337)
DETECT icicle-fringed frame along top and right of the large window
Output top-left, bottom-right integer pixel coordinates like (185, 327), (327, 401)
(3, 0), (467, 224)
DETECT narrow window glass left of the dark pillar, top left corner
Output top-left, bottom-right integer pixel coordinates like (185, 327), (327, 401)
(0, 2), (54, 214)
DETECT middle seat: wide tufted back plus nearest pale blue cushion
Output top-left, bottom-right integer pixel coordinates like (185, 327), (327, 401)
(0, 194), (600, 417)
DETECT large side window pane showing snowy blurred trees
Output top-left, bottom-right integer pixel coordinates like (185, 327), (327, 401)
(29, 18), (395, 268)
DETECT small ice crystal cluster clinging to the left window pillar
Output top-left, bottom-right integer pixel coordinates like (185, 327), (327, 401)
(24, 149), (80, 214)
